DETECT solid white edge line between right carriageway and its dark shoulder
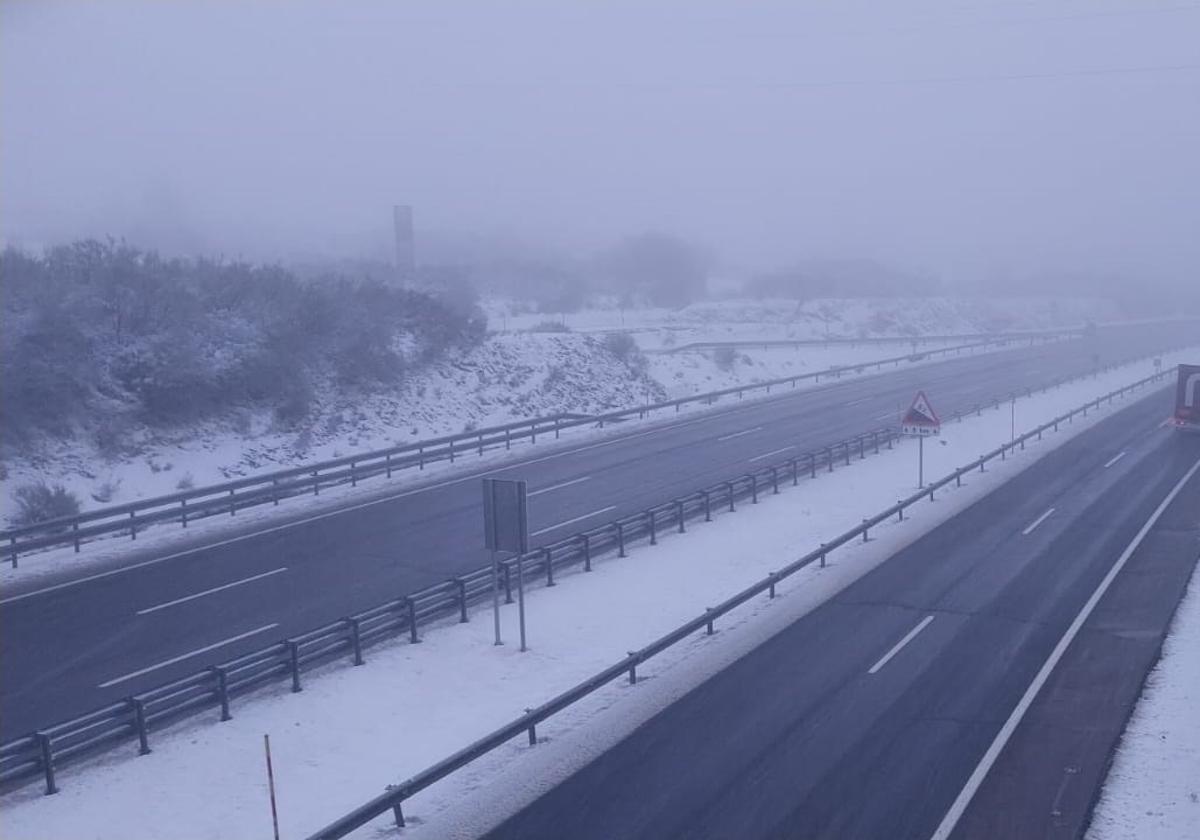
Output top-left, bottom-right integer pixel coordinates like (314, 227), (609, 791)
(930, 461), (1200, 840)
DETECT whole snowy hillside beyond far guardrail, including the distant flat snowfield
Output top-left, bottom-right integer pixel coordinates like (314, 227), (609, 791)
(0, 299), (1114, 517)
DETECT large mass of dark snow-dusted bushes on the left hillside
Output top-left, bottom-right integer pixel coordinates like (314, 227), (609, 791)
(0, 240), (486, 452)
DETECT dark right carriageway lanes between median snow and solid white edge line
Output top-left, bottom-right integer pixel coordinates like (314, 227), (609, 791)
(486, 395), (1200, 840)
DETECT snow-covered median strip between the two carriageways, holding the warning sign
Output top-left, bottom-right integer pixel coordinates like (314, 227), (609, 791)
(0, 350), (1190, 840)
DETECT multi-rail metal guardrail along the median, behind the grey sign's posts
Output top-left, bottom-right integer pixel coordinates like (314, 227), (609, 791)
(0, 430), (895, 793)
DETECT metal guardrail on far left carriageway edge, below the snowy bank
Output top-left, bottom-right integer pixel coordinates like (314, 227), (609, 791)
(0, 338), (1056, 568)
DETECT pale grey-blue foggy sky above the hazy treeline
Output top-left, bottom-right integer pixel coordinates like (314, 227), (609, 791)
(0, 0), (1200, 289)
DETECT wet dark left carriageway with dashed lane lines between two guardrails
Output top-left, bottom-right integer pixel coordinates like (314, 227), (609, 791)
(0, 324), (1194, 739)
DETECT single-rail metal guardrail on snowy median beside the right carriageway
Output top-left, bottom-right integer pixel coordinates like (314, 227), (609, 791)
(308, 371), (1171, 840)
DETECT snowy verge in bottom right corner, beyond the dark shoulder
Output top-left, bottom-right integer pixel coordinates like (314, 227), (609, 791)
(1087, 564), (1200, 840)
